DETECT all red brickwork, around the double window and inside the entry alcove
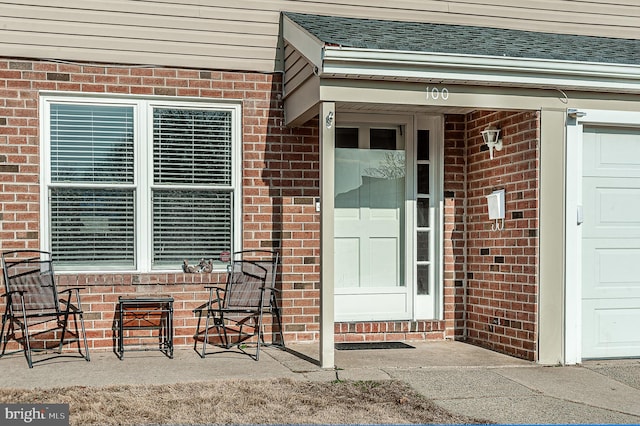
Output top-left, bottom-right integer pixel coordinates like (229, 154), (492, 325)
(0, 55), (538, 358)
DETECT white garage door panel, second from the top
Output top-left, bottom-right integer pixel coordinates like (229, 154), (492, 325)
(583, 178), (640, 238)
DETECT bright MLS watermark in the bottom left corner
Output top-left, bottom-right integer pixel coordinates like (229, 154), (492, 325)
(0, 404), (69, 426)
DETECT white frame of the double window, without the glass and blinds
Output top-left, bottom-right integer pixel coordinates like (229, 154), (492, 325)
(39, 93), (242, 273)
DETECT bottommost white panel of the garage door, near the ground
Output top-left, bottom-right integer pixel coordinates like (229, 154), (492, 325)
(582, 299), (640, 358)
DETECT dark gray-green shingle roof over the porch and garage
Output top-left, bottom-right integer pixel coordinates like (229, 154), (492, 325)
(284, 12), (640, 65)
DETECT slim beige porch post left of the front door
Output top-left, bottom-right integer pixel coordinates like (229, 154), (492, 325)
(319, 102), (336, 368)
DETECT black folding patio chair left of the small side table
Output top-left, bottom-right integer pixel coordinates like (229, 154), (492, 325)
(0, 250), (89, 368)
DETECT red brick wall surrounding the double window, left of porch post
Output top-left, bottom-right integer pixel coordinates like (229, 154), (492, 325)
(0, 59), (319, 348)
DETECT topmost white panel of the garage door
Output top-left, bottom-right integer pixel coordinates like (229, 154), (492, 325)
(583, 128), (640, 178)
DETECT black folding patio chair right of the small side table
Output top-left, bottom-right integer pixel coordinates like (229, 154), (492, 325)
(194, 250), (284, 361)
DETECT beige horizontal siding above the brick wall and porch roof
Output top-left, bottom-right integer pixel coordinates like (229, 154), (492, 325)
(0, 0), (640, 72)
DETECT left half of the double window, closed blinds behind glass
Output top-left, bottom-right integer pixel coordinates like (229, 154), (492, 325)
(49, 104), (135, 267)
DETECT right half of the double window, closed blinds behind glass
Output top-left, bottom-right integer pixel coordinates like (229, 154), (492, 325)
(153, 108), (233, 266)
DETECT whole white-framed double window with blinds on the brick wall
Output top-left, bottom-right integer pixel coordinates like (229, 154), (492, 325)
(44, 97), (239, 272)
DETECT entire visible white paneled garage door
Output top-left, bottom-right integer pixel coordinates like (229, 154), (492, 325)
(582, 127), (640, 358)
